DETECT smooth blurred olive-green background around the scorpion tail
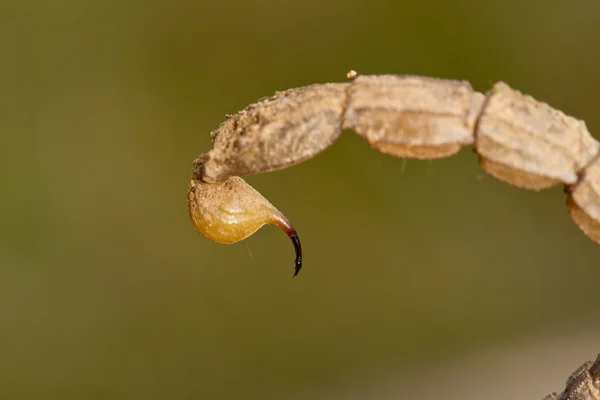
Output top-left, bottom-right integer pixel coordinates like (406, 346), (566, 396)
(0, 0), (600, 399)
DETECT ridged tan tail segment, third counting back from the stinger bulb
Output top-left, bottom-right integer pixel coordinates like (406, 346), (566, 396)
(475, 82), (599, 189)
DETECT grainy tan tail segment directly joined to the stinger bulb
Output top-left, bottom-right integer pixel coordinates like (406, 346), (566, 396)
(202, 83), (349, 182)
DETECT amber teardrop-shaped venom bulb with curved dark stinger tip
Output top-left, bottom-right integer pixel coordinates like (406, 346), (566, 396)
(188, 176), (302, 277)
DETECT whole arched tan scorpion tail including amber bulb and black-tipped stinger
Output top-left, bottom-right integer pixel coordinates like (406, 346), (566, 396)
(188, 71), (600, 276)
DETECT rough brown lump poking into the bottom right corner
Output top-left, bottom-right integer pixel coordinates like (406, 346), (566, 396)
(544, 354), (600, 400)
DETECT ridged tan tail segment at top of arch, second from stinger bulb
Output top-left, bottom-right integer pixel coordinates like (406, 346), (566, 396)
(343, 75), (484, 159)
